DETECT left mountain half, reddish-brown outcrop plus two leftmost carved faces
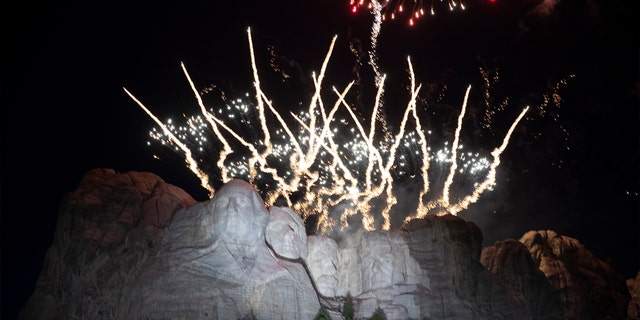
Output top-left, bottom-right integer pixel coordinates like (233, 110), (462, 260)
(20, 170), (320, 319)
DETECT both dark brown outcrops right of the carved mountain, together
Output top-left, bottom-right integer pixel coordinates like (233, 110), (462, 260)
(481, 230), (637, 320)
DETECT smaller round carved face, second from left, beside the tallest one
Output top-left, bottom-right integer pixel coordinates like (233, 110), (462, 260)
(265, 207), (307, 259)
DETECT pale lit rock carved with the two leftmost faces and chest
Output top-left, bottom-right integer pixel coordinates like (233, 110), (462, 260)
(125, 180), (320, 319)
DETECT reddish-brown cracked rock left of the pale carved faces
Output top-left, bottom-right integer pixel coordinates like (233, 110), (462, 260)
(20, 169), (196, 319)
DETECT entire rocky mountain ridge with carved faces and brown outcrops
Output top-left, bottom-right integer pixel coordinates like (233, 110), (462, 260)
(20, 169), (639, 320)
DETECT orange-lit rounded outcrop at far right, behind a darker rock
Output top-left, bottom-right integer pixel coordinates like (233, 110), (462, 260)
(520, 230), (630, 320)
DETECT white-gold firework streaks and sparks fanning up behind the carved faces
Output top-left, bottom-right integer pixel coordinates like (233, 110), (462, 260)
(124, 29), (528, 233)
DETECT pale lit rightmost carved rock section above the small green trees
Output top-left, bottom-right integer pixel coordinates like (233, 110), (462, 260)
(336, 230), (430, 319)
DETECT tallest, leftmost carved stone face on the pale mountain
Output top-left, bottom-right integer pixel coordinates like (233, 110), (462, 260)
(212, 179), (269, 258)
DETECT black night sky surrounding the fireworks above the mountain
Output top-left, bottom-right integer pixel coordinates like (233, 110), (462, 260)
(0, 0), (640, 319)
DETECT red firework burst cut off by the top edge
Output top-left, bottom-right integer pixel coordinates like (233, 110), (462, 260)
(349, 0), (466, 26)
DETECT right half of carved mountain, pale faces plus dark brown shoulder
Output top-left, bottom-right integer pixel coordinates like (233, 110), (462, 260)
(307, 216), (531, 319)
